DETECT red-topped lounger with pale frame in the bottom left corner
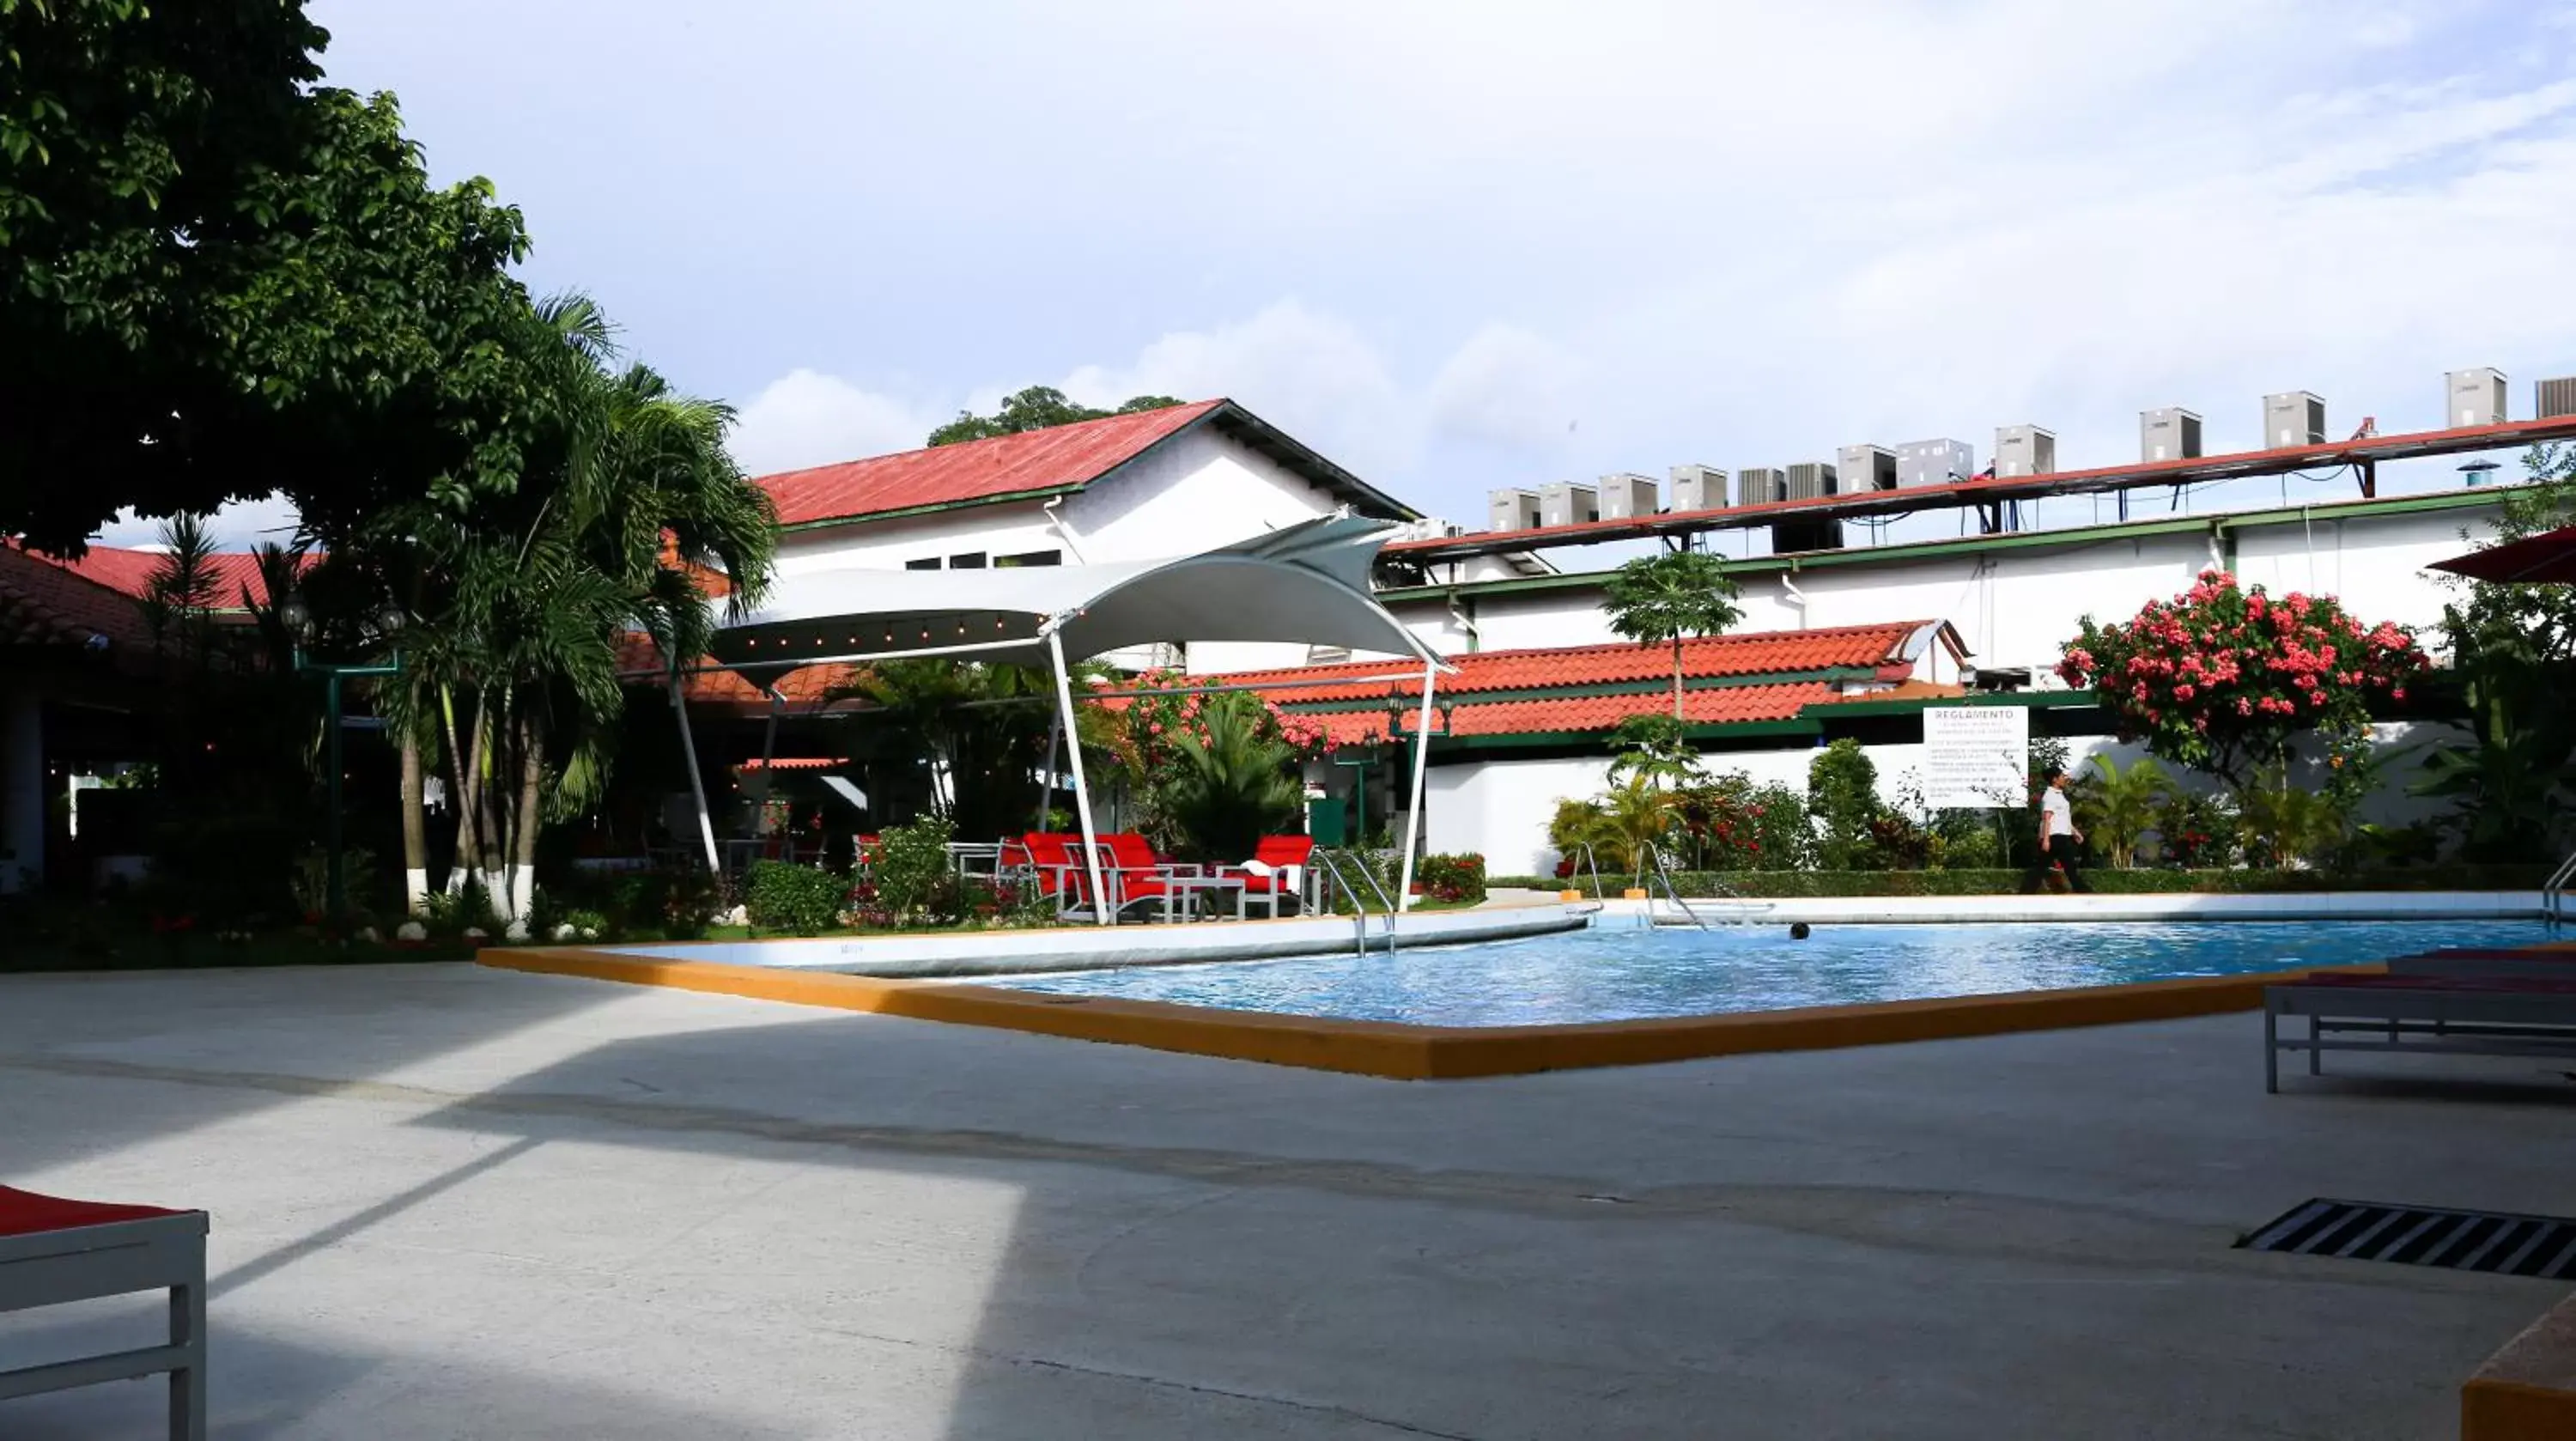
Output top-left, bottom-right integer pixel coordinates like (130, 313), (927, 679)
(0, 1186), (206, 1441)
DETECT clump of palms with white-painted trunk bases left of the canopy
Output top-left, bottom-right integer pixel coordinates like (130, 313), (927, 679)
(337, 296), (775, 918)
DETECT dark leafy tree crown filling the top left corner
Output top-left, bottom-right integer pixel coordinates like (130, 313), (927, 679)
(0, 0), (541, 551)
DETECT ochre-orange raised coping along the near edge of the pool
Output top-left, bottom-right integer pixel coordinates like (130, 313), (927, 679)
(477, 946), (2383, 1080)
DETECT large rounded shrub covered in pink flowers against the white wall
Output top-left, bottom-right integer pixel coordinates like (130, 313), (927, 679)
(2058, 569), (2427, 789)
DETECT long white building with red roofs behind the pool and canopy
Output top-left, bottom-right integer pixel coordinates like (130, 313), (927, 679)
(760, 399), (2499, 874)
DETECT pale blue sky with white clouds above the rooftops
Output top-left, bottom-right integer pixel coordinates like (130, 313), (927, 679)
(111, 0), (2576, 554)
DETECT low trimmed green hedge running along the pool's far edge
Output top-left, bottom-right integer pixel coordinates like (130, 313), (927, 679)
(1486, 866), (2550, 900)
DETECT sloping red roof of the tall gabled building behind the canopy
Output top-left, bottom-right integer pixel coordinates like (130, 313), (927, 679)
(752, 399), (1229, 526)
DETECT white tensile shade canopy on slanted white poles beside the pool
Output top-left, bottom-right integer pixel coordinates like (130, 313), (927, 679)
(675, 513), (1440, 923)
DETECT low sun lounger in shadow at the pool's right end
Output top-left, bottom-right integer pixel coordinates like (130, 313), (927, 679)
(2262, 957), (2576, 1091)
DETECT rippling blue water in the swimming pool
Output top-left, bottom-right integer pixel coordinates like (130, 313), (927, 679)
(994, 921), (2548, 1026)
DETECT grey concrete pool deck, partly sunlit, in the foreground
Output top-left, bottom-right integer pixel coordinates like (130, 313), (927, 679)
(0, 964), (2576, 1441)
